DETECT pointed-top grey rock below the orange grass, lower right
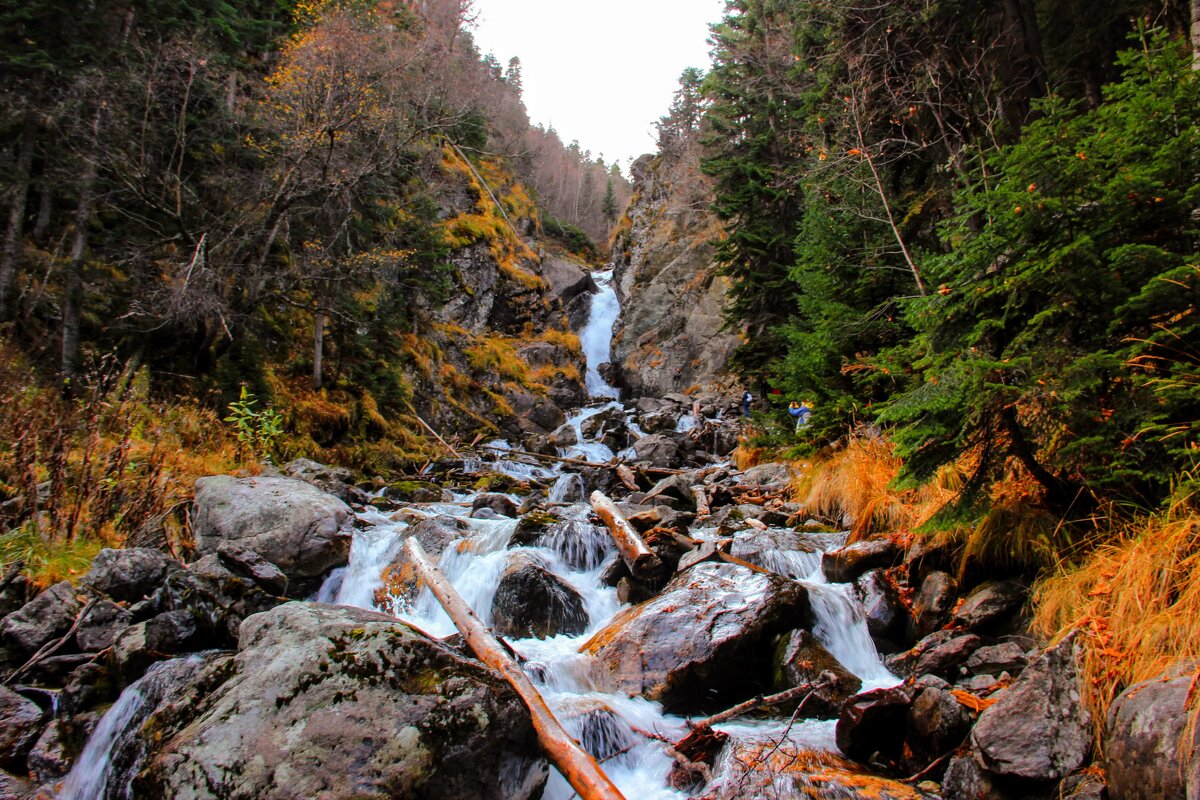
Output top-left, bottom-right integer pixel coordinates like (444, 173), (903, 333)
(971, 636), (1092, 781)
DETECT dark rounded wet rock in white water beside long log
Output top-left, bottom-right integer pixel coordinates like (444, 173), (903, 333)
(492, 553), (588, 639)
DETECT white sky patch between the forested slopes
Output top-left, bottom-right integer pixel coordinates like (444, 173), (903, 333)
(473, 0), (725, 175)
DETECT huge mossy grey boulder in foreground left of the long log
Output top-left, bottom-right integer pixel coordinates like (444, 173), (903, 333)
(136, 603), (546, 800)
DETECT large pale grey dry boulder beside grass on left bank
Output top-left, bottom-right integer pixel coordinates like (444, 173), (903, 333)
(192, 475), (352, 581)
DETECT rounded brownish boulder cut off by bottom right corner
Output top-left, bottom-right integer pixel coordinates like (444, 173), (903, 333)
(1104, 667), (1200, 800)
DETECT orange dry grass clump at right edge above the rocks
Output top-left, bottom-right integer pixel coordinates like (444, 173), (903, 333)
(1034, 511), (1200, 741)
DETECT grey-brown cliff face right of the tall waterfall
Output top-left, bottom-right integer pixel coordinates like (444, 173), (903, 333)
(613, 156), (739, 396)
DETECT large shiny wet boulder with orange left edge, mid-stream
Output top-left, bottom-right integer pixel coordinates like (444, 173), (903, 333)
(581, 563), (812, 712)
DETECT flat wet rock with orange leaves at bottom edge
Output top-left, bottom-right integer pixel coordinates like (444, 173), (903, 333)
(703, 740), (936, 800)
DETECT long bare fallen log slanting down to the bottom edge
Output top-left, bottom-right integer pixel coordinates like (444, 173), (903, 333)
(404, 536), (624, 800)
